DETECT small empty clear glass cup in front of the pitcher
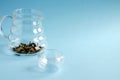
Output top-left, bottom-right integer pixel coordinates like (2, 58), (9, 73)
(38, 49), (64, 73)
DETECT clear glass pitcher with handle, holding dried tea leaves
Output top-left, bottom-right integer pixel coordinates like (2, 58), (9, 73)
(0, 9), (47, 55)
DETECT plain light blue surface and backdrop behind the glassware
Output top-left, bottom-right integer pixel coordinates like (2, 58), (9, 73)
(0, 0), (120, 80)
